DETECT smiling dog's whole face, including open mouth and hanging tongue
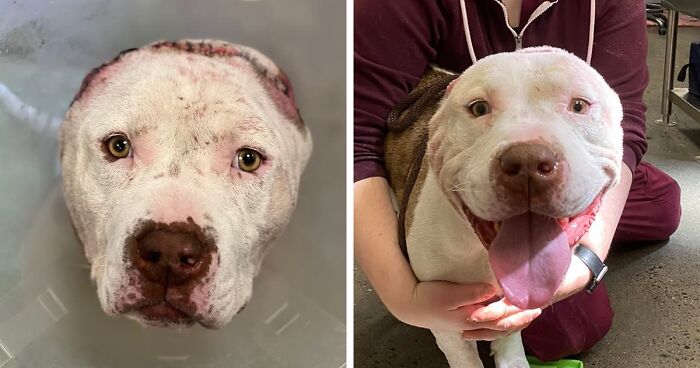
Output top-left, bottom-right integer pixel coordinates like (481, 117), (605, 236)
(428, 48), (622, 308)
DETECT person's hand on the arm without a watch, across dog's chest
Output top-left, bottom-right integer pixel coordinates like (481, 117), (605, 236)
(391, 281), (495, 331)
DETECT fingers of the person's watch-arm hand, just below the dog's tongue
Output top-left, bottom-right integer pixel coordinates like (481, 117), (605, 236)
(462, 298), (542, 341)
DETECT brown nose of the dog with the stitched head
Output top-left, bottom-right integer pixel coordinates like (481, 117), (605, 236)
(131, 228), (211, 286)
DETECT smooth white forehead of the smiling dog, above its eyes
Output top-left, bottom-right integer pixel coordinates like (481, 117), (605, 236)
(455, 48), (609, 99)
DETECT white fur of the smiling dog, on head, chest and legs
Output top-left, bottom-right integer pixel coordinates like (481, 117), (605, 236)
(407, 48), (622, 368)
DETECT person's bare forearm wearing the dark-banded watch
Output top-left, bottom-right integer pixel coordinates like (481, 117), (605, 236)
(555, 164), (632, 301)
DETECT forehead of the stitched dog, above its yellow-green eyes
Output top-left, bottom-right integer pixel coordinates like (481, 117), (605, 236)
(71, 41), (300, 139)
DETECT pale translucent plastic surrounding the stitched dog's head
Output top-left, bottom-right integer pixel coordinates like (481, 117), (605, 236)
(0, 0), (345, 368)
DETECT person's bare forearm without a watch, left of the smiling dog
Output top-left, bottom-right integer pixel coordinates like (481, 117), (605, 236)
(353, 177), (417, 319)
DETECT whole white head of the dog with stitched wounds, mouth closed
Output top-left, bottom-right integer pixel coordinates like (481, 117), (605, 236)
(60, 41), (311, 328)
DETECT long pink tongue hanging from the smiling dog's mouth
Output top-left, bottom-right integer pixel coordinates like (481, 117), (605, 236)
(489, 212), (571, 309)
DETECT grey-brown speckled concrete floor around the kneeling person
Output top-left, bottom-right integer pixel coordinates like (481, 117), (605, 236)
(354, 28), (700, 368)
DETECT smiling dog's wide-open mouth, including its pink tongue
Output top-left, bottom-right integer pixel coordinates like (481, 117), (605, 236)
(462, 191), (604, 309)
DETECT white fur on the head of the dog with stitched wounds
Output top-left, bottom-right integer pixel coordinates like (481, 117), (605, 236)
(61, 41), (311, 327)
